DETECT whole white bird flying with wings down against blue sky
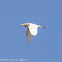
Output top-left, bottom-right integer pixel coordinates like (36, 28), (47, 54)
(21, 23), (45, 42)
